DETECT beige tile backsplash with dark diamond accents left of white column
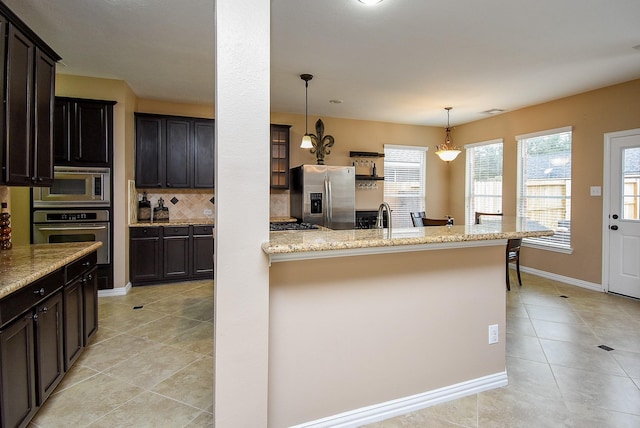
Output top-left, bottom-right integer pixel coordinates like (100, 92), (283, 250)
(131, 189), (216, 220)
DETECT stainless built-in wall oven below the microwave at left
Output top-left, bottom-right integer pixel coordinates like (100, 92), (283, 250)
(33, 210), (111, 265)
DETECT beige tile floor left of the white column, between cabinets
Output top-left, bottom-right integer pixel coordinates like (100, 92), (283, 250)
(30, 281), (213, 428)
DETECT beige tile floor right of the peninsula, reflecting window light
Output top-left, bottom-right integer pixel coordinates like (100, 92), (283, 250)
(368, 273), (640, 428)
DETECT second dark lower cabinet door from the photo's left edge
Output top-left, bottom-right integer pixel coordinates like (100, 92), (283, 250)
(35, 292), (64, 405)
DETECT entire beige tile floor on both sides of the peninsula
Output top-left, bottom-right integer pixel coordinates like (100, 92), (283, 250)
(25, 274), (640, 428)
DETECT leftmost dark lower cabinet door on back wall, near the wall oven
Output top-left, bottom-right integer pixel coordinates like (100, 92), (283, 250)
(129, 227), (162, 284)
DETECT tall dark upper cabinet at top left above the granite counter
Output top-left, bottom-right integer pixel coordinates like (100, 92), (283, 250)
(0, 3), (60, 186)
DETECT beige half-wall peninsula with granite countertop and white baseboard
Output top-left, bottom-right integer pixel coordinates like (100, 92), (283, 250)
(262, 218), (552, 427)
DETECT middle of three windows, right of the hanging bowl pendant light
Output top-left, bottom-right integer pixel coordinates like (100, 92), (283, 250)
(464, 139), (503, 224)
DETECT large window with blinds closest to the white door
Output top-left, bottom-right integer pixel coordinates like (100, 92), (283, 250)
(516, 127), (571, 251)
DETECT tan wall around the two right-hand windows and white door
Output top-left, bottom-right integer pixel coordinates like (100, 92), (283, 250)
(449, 80), (640, 284)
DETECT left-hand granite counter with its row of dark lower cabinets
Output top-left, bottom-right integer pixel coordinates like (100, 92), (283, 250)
(0, 241), (102, 426)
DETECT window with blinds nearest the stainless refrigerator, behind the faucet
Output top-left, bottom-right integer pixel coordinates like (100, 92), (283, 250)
(384, 145), (427, 227)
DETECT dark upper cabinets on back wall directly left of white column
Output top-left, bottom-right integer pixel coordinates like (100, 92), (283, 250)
(135, 113), (215, 189)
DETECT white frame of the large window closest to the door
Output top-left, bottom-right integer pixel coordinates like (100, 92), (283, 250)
(515, 126), (573, 254)
